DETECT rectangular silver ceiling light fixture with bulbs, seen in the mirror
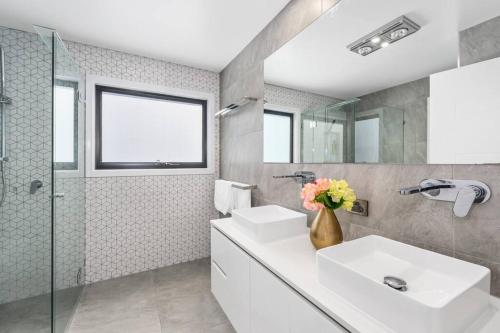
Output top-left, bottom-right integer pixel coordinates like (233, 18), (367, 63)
(347, 16), (420, 56)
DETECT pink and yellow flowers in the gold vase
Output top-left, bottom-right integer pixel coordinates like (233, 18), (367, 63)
(300, 178), (356, 211)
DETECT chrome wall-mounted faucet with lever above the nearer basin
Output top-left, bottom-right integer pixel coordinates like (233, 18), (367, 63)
(399, 179), (491, 217)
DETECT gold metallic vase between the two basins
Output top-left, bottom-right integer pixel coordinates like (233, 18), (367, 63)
(309, 208), (343, 250)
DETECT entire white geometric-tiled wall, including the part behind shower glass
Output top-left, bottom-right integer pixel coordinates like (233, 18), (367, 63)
(0, 27), (219, 303)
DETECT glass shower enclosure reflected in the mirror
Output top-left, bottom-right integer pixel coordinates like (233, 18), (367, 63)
(300, 98), (405, 163)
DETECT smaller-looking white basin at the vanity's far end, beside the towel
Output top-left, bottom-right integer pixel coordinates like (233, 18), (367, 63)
(231, 205), (307, 242)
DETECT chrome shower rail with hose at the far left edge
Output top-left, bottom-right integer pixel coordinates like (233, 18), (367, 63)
(0, 46), (11, 207)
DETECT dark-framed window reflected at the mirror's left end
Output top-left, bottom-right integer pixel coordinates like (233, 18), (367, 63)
(264, 110), (294, 163)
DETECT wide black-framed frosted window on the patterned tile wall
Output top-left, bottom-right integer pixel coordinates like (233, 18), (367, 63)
(96, 86), (207, 169)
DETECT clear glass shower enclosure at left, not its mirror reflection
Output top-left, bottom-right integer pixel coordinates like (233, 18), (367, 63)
(0, 26), (85, 332)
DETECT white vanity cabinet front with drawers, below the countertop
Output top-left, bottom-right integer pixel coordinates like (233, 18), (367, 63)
(211, 228), (347, 333)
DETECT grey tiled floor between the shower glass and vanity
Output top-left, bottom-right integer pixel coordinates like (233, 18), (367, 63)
(69, 258), (234, 333)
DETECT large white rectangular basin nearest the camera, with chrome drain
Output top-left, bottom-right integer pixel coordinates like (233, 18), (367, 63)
(316, 236), (490, 333)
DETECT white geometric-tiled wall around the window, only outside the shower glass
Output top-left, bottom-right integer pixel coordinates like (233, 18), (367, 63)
(67, 42), (219, 282)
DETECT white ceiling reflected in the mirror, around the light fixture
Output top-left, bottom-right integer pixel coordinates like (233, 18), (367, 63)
(264, 0), (500, 99)
